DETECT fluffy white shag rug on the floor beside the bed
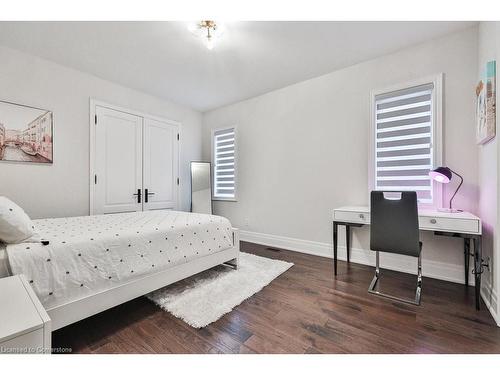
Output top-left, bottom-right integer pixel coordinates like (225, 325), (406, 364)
(146, 253), (293, 328)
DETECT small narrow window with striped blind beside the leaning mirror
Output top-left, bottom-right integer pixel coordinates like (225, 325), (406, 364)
(212, 128), (236, 200)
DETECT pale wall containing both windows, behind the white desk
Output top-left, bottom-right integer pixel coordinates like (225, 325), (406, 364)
(203, 28), (478, 281)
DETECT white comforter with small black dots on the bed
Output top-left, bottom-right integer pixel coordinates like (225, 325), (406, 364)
(6, 210), (232, 309)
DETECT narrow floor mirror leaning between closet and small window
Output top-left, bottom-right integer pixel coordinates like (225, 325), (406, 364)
(191, 161), (212, 214)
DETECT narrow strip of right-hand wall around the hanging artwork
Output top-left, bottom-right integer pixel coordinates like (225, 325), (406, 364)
(476, 22), (500, 323)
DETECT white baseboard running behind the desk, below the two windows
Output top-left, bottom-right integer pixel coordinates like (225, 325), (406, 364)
(240, 230), (474, 285)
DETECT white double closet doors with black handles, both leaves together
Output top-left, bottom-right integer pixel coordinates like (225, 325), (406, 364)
(93, 106), (179, 214)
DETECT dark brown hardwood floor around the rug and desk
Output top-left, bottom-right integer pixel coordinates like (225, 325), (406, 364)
(52, 242), (500, 353)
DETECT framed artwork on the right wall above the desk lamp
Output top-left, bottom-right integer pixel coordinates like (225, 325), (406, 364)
(476, 61), (496, 145)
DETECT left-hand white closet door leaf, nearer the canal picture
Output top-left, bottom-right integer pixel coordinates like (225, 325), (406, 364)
(94, 106), (143, 214)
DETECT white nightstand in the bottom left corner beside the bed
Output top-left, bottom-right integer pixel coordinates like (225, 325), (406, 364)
(0, 275), (52, 353)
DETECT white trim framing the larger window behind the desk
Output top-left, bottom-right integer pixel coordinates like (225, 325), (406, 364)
(368, 73), (444, 208)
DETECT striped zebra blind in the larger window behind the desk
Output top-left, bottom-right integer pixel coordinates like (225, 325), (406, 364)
(374, 83), (434, 203)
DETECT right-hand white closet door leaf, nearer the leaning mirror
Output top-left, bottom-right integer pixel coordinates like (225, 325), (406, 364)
(143, 118), (179, 210)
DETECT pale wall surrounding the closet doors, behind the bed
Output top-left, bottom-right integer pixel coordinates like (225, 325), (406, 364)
(0, 47), (201, 218)
